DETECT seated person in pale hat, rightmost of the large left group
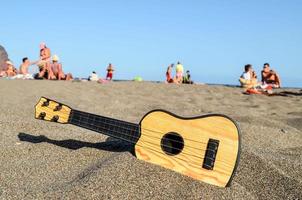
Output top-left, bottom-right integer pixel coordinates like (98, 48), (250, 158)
(49, 55), (73, 81)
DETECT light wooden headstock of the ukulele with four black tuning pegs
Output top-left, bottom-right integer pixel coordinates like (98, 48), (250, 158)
(35, 97), (71, 124)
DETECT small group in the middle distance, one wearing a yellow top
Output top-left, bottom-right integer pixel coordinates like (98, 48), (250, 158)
(166, 62), (193, 84)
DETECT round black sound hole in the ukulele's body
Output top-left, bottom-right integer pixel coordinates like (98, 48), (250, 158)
(161, 132), (184, 156)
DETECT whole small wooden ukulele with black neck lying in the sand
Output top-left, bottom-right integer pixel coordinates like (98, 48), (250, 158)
(35, 97), (240, 187)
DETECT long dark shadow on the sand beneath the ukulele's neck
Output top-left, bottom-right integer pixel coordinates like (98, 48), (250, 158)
(18, 132), (134, 154)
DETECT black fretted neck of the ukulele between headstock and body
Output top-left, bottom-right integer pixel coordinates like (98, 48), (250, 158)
(68, 110), (140, 144)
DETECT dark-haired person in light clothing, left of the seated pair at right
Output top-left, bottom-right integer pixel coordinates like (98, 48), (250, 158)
(239, 64), (258, 88)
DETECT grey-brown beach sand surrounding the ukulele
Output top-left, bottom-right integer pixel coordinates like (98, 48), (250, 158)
(0, 80), (302, 199)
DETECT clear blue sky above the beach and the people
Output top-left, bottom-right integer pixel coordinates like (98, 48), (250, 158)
(0, 0), (302, 87)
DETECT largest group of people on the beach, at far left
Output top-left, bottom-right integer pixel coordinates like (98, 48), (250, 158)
(0, 43), (73, 80)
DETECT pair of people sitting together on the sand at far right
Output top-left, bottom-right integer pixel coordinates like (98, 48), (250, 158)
(239, 63), (281, 93)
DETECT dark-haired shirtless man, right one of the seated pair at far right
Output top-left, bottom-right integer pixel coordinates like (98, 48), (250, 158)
(261, 63), (281, 88)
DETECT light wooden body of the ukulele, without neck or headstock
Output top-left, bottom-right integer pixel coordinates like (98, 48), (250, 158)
(135, 110), (240, 187)
